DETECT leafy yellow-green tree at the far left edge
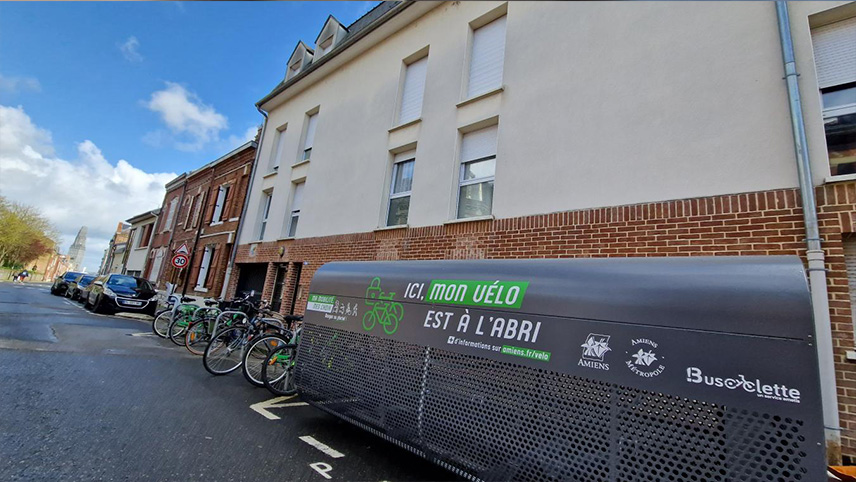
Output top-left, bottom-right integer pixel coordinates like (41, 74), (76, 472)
(0, 196), (59, 267)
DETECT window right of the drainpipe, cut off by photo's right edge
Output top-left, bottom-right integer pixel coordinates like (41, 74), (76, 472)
(811, 17), (856, 176)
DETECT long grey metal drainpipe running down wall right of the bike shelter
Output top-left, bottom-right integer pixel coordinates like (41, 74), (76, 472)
(776, 0), (841, 464)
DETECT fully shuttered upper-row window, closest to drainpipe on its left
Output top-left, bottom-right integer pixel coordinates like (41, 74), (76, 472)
(467, 15), (506, 98)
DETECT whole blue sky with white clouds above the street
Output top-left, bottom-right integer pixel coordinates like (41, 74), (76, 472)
(0, 2), (378, 271)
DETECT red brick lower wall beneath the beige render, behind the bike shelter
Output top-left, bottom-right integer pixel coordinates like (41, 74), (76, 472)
(230, 182), (856, 455)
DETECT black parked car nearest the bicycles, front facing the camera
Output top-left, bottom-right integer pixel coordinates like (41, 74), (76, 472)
(84, 273), (157, 316)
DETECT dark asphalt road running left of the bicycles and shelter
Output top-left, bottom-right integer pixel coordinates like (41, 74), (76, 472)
(0, 283), (458, 482)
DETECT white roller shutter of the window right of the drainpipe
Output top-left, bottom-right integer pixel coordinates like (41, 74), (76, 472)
(811, 17), (856, 89)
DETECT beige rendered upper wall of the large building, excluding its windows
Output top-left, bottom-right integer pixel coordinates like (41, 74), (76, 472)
(240, 2), (842, 243)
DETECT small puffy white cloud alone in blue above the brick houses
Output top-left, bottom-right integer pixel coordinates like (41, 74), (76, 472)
(144, 82), (229, 151)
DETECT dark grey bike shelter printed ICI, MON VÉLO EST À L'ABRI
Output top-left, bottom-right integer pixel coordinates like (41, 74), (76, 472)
(296, 256), (825, 481)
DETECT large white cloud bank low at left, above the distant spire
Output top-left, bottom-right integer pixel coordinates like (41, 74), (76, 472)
(0, 105), (176, 271)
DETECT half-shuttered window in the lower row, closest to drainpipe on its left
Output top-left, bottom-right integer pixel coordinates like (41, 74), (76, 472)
(458, 126), (497, 219)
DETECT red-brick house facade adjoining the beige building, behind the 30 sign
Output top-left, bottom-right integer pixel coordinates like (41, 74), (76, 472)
(147, 141), (256, 298)
